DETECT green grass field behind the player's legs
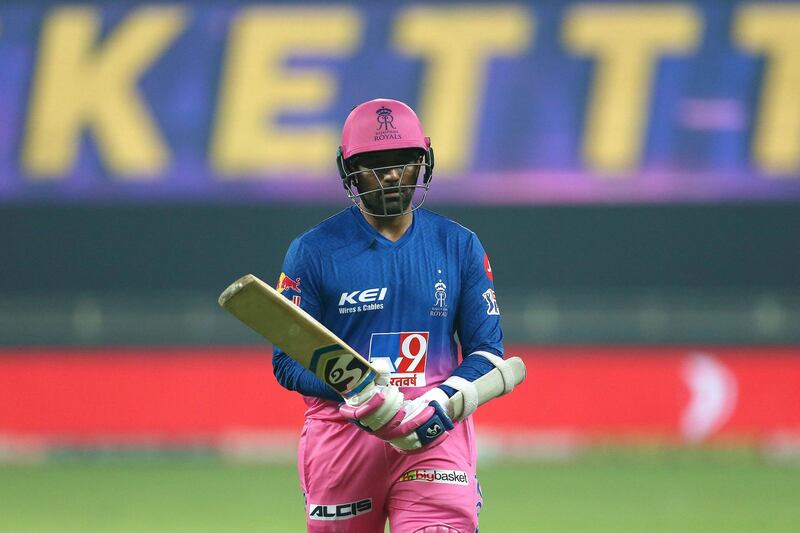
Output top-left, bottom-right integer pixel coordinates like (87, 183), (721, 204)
(0, 450), (800, 533)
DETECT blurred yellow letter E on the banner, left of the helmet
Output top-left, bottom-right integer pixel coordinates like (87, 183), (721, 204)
(211, 6), (360, 179)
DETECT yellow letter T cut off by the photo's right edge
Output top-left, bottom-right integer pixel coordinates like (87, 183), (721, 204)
(733, 4), (800, 178)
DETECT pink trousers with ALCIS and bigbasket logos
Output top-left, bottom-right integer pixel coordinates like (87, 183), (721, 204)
(298, 419), (482, 533)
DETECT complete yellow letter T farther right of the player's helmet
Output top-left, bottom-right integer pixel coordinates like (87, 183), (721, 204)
(563, 3), (702, 175)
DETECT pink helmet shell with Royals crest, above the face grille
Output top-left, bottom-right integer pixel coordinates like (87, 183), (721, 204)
(341, 98), (431, 159)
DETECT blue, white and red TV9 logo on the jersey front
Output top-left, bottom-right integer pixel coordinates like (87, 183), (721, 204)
(369, 331), (429, 387)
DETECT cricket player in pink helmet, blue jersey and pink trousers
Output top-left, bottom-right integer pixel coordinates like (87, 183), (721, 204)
(273, 99), (513, 533)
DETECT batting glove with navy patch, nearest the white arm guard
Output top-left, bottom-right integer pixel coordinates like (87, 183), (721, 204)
(382, 387), (455, 453)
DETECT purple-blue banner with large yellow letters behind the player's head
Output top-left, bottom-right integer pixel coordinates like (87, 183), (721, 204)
(0, 0), (800, 205)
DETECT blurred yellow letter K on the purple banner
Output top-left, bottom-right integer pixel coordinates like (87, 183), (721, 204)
(22, 6), (185, 180)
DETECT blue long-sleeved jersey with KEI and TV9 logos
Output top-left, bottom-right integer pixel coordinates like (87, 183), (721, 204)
(273, 206), (503, 414)
